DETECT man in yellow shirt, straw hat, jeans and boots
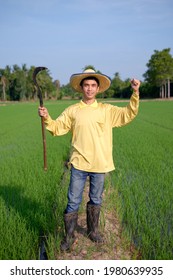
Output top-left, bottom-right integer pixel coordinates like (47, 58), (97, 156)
(39, 69), (140, 251)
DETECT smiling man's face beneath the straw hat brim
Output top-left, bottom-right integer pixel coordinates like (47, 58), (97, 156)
(82, 80), (99, 100)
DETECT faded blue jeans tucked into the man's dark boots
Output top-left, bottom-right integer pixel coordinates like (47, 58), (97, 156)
(65, 166), (105, 213)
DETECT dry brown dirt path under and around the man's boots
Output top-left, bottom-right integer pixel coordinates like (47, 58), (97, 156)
(56, 175), (137, 260)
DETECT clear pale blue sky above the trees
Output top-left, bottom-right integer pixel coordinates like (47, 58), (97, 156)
(0, 0), (173, 85)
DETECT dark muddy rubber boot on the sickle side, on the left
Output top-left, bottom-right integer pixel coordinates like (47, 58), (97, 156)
(60, 212), (78, 251)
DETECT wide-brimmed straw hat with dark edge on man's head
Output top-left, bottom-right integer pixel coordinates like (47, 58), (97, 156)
(70, 69), (111, 93)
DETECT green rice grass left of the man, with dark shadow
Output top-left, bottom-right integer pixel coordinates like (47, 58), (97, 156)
(0, 101), (70, 259)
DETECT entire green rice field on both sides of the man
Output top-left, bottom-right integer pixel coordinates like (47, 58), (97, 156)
(0, 101), (173, 260)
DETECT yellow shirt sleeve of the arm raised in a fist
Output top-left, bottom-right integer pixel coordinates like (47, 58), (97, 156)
(110, 92), (139, 127)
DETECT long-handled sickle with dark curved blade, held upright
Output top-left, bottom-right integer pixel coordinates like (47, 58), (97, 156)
(33, 67), (47, 171)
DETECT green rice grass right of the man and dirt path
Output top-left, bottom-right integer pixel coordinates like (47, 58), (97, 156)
(113, 99), (173, 259)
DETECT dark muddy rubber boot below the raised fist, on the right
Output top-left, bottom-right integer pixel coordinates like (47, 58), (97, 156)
(87, 203), (104, 243)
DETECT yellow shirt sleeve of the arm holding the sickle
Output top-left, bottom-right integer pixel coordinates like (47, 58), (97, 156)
(44, 109), (71, 136)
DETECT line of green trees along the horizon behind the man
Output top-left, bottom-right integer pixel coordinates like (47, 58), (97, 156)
(0, 48), (173, 101)
